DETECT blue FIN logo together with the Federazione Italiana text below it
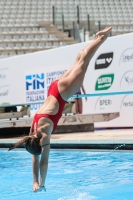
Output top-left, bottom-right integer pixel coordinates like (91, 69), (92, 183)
(25, 73), (45, 104)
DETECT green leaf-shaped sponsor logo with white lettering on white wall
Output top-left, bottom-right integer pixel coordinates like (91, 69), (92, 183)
(95, 74), (114, 91)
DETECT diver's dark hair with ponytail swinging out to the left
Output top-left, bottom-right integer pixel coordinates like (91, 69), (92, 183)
(8, 136), (41, 155)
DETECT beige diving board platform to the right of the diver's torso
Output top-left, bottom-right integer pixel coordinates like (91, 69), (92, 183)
(55, 112), (119, 133)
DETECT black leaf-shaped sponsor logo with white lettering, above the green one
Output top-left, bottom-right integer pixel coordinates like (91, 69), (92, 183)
(95, 52), (113, 69)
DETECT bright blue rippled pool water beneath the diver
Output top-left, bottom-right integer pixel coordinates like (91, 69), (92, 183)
(0, 150), (133, 200)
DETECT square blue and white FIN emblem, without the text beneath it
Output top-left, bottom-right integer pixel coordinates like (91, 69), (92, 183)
(26, 73), (44, 91)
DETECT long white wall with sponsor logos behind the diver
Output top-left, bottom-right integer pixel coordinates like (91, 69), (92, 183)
(0, 33), (133, 127)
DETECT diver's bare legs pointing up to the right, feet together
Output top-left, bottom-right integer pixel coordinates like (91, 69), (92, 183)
(58, 27), (112, 100)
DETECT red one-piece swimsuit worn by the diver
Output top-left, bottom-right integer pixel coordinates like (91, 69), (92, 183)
(31, 80), (66, 133)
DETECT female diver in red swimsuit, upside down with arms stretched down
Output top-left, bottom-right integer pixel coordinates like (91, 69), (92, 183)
(9, 27), (112, 192)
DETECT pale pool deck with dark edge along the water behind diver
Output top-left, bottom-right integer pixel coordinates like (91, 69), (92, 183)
(0, 129), (133, 150)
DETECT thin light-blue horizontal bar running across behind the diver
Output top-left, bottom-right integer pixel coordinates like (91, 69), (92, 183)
(0, 91), (133, 108)
